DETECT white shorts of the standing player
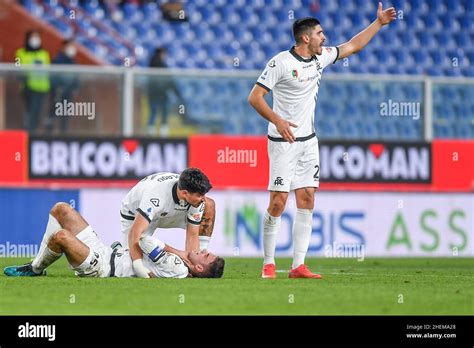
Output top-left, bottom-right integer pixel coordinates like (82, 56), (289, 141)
(268, 136), (319, 192)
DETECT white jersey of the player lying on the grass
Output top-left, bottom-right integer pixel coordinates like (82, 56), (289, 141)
(115, 248), (189, 279)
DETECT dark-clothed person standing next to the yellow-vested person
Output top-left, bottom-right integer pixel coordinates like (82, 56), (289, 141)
(46, 39), (79, 134)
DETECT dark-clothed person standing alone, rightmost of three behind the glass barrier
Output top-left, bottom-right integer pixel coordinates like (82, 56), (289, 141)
(147, 47), (181, 136)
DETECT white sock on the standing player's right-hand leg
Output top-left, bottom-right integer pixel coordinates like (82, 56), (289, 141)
(291, 208), (313, 269)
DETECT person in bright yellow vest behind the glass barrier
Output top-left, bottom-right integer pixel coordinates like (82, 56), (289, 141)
(15, 30), (50, 131)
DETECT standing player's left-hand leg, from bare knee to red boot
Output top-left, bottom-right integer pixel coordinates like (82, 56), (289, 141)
(262, 191), (288, 279)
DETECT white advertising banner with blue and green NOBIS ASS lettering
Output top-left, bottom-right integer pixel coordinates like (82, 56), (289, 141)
(80, 189), (474, 257)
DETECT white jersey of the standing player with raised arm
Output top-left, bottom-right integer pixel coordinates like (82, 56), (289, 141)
(257, 47), (339, 138)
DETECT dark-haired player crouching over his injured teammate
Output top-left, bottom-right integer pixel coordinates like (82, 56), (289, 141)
(120, 168), (215, 278)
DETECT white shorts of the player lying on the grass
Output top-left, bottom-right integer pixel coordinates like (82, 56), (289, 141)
(71, 226), (112, 278)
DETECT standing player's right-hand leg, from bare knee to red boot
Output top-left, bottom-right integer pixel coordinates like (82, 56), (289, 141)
(288, 187), (321, 279)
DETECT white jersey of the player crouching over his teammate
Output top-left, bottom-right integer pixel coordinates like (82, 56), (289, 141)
(120, 173), (204, 236)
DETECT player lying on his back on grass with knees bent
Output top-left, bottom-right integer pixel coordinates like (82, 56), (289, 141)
(4, 203), (225, 278)
